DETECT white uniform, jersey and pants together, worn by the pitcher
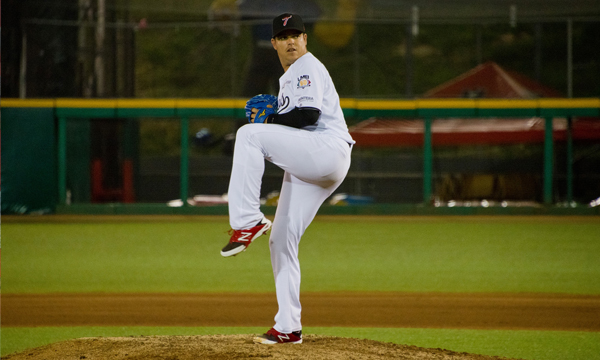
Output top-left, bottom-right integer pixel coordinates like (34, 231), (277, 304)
(228, 52), (354, 333)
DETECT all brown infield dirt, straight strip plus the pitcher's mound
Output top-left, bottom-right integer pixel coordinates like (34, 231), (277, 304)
(2, 292), (600, 360)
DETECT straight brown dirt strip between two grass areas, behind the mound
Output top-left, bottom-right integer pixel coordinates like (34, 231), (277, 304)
(1, 292), (600, 331)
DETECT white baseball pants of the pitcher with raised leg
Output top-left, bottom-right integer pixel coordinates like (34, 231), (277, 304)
(228, 124), (351, 333)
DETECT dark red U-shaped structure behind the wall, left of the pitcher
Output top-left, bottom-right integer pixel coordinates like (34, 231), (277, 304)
(91, 159), (135, 203)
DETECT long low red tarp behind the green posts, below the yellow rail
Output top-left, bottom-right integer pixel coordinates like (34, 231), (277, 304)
(350, 118), (600, 147)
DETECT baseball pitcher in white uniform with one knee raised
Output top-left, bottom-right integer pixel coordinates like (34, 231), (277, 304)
(221, 13), (354, 344)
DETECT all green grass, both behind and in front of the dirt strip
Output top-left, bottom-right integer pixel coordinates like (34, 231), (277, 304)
(2, 216), (600, 360)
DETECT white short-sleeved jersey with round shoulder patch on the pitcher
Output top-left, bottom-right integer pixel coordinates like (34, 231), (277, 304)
(277, 52), (355, 144)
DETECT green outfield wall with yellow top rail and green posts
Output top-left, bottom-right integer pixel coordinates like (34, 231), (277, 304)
(1, 98), (600, 214)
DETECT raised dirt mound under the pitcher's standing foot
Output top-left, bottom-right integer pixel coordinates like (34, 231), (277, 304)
(5, 335), (520, 360)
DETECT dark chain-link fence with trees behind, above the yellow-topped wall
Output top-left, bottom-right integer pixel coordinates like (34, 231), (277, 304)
(2, 0), (600, 98)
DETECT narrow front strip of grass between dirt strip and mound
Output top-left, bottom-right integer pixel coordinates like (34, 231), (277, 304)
(2, 327), (600, 360)
